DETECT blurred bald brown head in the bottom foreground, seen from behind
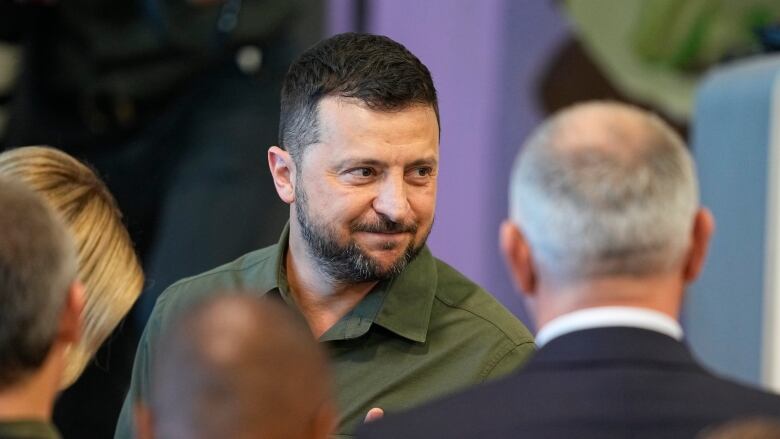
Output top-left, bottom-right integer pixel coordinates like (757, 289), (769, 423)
(150, 292), (331, 439)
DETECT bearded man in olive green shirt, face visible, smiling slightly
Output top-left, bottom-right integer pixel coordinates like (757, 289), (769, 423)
(116, 33), (534, 438)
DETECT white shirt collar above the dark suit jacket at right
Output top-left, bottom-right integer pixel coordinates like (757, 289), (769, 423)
(536, 306), (683, 347)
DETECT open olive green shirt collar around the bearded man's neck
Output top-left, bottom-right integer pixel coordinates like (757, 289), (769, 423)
(268, 224), (438, 343)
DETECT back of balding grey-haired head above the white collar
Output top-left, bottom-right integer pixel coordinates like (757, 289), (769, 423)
(510, 102), (698, 282)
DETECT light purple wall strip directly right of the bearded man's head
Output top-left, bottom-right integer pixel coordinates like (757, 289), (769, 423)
(368, 0), (503, 302)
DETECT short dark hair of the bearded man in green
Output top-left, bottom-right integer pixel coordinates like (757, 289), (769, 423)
(279, 32), (439, 162)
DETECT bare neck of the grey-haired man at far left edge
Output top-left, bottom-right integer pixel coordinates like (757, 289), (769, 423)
(0, 344), (64, 422)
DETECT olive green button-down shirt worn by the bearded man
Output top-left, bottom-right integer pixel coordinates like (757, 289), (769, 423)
(115, 229), (534, 439)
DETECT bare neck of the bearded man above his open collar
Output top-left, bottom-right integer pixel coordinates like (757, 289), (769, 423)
(285, 233), (377, 338)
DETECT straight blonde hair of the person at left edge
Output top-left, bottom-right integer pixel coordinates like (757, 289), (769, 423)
(0, 146), (144, 388)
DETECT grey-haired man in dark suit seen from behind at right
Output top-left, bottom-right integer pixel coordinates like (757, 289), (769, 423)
(364, 102), (780, 439)
